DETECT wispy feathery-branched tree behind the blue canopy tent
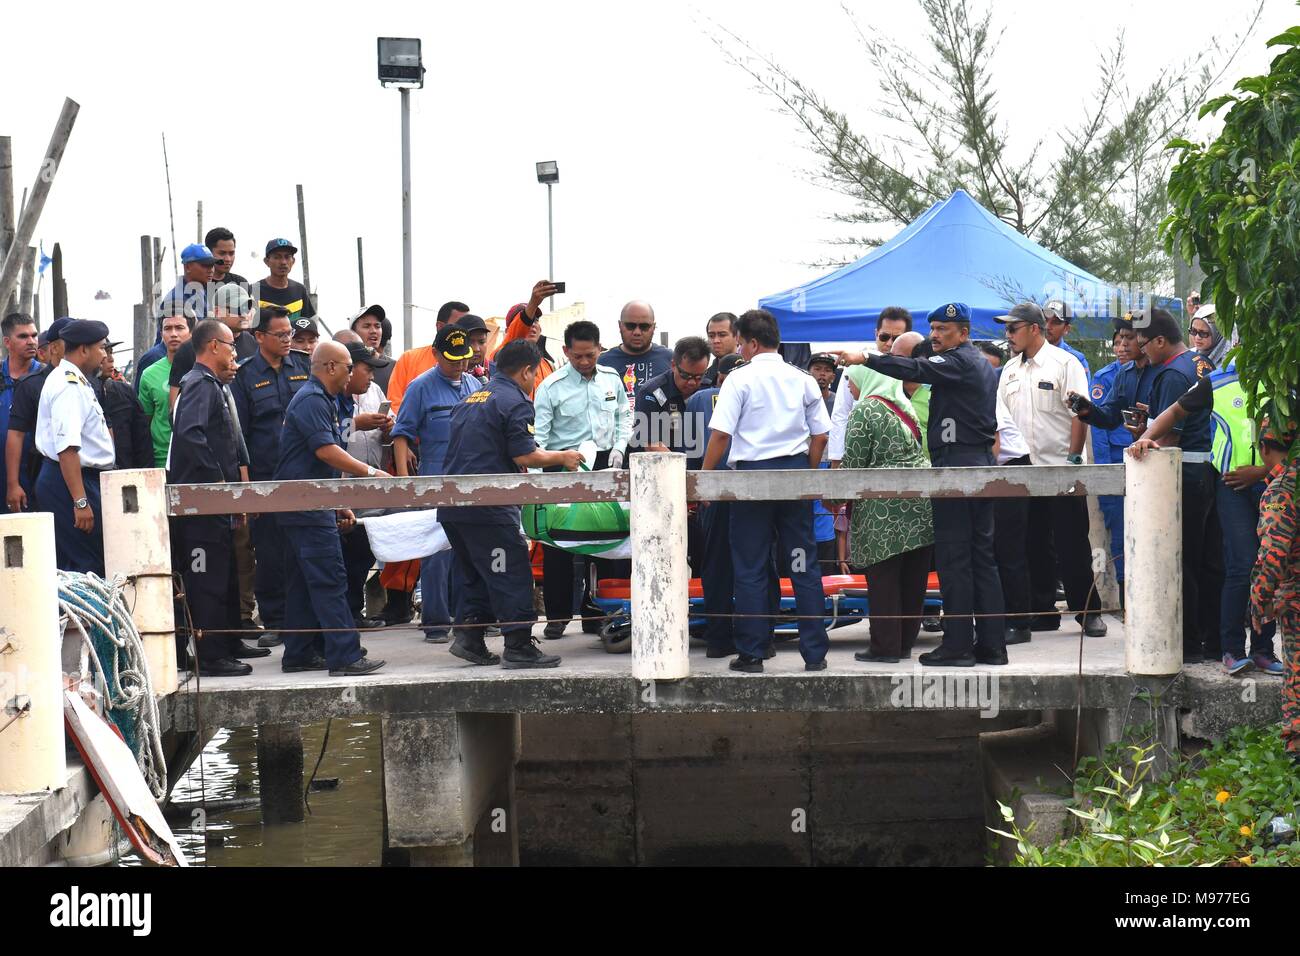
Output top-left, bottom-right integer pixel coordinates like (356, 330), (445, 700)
(711, 0), (1262, 289)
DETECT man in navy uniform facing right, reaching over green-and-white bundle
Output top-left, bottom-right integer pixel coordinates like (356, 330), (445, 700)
(439, 338), (582, 669)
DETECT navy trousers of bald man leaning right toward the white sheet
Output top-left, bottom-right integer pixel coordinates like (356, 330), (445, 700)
(282, 524), (361, 670)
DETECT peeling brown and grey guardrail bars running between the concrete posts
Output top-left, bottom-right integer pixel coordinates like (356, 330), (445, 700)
(159, 464), (1125, 516)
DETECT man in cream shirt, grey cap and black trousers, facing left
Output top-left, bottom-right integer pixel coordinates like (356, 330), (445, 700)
(997, 302), (1106, 640)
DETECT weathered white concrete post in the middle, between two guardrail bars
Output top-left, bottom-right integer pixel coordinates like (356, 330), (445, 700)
(628, 451), (690, 680)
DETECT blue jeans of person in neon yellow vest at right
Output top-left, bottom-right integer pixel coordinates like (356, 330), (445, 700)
(1211, 477), (1277, 657)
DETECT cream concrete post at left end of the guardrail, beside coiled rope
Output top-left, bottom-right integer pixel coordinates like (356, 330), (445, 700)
(99, 468), (177, 696)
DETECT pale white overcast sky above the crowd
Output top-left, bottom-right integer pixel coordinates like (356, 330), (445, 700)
(0, 0), (1300, 358)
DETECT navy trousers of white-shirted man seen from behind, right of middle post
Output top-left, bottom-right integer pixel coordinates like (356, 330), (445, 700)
(729, 455), (831, 663)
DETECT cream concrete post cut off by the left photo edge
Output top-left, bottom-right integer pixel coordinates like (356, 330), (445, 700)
(0, 512), (68, 793)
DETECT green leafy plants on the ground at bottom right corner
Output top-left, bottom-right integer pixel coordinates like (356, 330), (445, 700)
(993, 727), (1300, 866)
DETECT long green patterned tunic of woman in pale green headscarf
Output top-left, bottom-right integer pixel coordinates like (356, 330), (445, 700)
(840, 392), (935, 574)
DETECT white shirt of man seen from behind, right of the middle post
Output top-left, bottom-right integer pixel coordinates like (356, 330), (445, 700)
(709, 352), (831, 466)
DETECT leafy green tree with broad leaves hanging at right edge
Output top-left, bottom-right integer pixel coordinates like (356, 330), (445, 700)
(1161, 26), (1300, 416)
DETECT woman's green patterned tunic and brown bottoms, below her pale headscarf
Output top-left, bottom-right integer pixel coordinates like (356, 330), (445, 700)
(840, 394), (935, 663)
